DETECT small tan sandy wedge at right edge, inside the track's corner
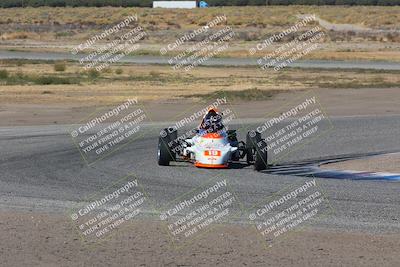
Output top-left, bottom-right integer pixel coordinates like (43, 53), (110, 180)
(321, 153), (400, 173)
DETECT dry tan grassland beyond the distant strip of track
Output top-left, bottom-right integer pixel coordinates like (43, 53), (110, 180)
(0, 6), (400, 61)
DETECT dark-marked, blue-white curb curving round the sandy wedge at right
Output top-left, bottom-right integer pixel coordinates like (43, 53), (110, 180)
(263, 151), (400, 181)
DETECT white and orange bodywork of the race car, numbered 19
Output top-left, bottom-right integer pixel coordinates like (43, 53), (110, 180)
(183, 131), (238, 168)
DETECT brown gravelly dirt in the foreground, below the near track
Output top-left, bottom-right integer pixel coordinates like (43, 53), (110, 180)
(0, 211), (400, 266)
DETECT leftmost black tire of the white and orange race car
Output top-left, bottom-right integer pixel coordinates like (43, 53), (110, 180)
(157, 128), (178, 166)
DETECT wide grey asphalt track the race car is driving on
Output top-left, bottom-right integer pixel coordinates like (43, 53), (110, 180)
(0, 115), (400, 233)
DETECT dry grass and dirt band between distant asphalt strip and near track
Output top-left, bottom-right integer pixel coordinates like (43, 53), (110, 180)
(0, 60), (400, 126)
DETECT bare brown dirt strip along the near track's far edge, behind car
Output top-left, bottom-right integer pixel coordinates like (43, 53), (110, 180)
(0, 88), (400, 126)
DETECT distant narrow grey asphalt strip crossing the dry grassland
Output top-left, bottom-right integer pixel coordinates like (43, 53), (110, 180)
(0, 50), (400, 70)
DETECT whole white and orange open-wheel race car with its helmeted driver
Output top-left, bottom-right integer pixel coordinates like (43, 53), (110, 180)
(158, 109), (268, 171)
